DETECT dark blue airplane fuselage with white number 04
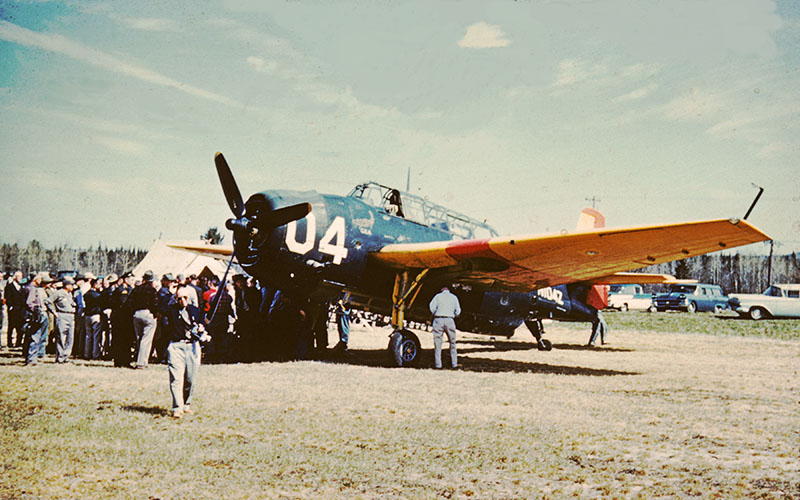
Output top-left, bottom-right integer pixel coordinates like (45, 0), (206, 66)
(234, 191), (591, 336)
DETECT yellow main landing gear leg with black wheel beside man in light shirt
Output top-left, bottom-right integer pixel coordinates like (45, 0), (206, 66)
(387, 269), (428, 366)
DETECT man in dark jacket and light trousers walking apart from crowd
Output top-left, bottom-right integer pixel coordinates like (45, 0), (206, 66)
(164, 287), (211, 418)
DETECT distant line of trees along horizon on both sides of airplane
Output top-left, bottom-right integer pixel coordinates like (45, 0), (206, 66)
(0, 238), (800, 293)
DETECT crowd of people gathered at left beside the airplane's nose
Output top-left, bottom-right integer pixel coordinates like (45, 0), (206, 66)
(0, 271), (370, 369)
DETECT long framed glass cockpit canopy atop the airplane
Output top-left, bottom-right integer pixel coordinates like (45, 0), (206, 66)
(348, 181), (497, 239)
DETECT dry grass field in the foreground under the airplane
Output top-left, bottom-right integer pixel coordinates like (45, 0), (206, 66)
(0, 313), (800, 499)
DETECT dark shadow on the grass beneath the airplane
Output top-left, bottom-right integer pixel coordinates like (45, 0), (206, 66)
(316, 350), (640, 377)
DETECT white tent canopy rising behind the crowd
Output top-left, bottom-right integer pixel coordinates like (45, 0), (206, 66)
(133, 240), (242, 279)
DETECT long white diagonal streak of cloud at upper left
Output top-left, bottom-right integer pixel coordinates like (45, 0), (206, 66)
(0, 21), (242, 107)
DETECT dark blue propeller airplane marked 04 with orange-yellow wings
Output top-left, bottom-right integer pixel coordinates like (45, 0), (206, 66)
(178, 153), (770, 366)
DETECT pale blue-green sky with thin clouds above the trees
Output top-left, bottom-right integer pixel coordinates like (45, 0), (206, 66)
(0, 0), (800, 253)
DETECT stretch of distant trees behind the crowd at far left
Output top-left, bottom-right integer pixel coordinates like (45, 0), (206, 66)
(0, 240), (147, 276)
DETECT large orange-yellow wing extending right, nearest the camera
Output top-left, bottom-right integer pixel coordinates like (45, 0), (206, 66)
(371, 219), (770, 290)
